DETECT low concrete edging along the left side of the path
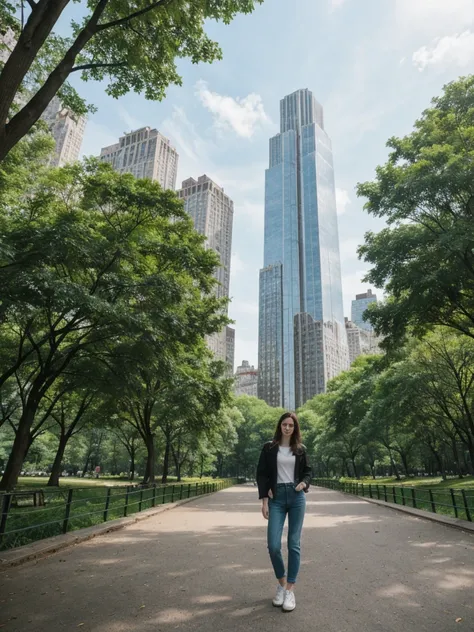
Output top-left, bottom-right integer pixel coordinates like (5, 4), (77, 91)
(0, 492), (218, 572)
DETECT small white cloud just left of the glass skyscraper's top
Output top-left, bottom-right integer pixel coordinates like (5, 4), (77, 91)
(196, 81), (269, 138)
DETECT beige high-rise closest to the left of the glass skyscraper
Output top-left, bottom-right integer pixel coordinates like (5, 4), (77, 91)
(178, 175), (234, 364)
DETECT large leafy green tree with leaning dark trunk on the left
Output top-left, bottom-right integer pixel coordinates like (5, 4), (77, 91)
(0, 162), (225, 489)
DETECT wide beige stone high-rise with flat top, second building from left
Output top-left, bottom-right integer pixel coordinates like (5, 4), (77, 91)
(100, 127), (179, 189)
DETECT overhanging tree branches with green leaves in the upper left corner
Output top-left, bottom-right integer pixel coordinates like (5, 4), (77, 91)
(0, 0), (261, 162)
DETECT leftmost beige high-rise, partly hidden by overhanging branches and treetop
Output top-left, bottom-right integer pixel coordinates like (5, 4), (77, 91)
(41, 97), (87, 167)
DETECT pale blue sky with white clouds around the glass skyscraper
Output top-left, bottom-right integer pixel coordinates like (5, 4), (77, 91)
(69, 0), (474, 366)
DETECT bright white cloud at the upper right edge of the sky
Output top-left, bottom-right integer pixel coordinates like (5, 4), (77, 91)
(412, 31), (474, 72)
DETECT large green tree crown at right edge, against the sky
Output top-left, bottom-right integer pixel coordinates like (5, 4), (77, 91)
(358, 76), (474, 347)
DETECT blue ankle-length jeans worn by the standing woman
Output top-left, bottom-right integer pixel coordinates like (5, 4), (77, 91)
(267, 483), (306, 584)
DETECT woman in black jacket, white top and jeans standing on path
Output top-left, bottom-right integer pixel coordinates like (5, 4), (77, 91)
(257, 413), (311, 612)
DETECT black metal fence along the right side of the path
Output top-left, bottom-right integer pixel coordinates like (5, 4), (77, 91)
(313, 478), (474, 522)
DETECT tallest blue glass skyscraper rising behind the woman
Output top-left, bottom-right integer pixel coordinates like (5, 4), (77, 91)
(258, 90), (349, 409)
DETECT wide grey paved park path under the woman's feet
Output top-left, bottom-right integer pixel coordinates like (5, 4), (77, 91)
(0, 487), (474, 632)
